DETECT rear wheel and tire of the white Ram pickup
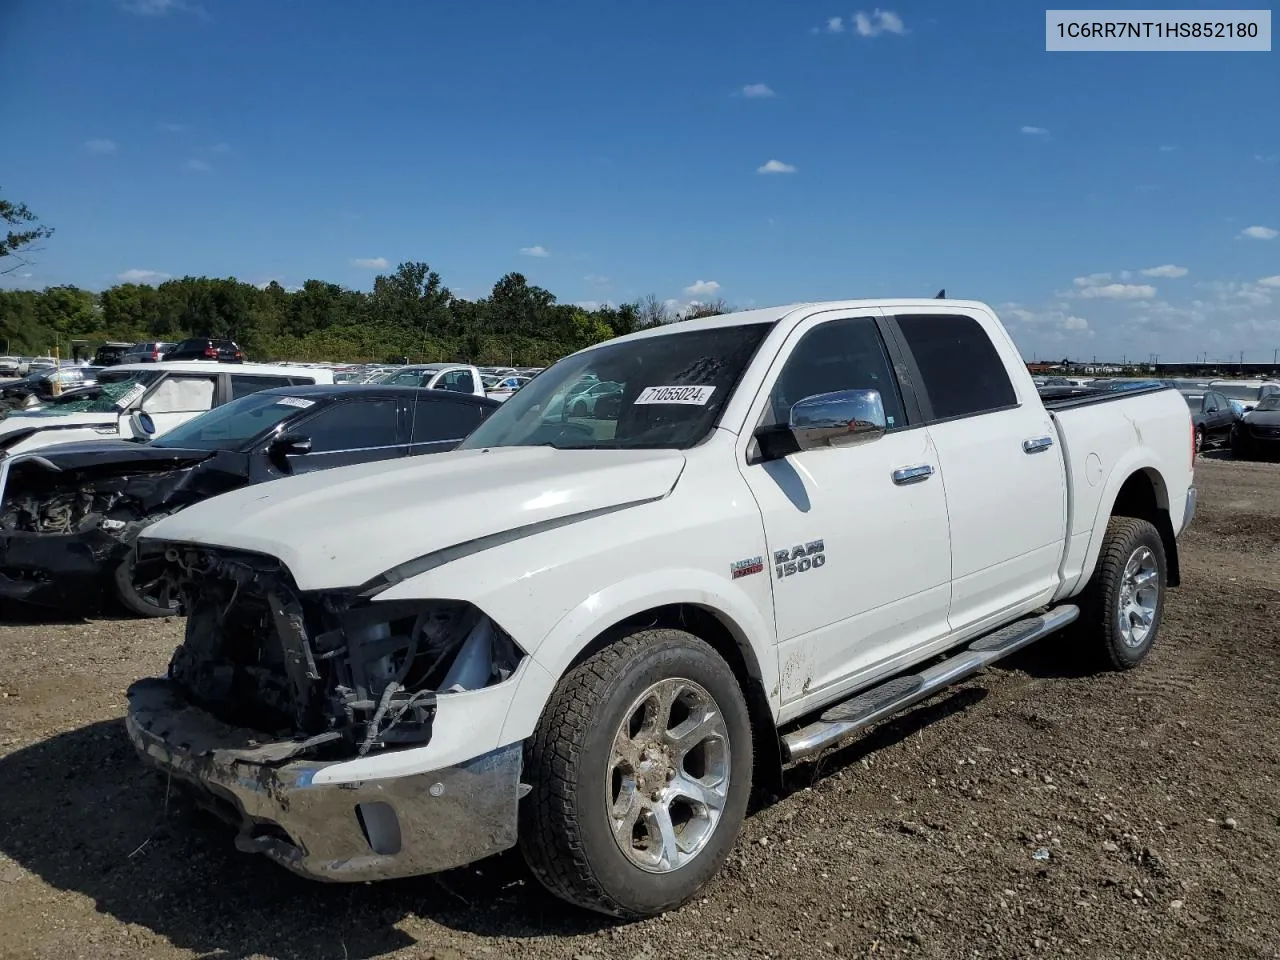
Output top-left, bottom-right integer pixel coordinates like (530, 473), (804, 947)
(1079, 517), (1169, 669)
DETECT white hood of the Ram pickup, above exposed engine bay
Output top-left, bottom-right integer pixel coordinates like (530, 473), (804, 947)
(145, 447), (685, 590)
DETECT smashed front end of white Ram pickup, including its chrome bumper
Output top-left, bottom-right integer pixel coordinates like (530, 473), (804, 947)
(128, 540), (525, 881)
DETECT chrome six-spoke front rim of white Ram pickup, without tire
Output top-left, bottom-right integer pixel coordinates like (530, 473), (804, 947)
(604, 678), (730, 873)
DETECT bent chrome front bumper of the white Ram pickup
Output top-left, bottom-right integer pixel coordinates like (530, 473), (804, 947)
(125, 678), (522, 882)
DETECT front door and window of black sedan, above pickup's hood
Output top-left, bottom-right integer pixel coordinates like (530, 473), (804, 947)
(285, 398), (408, 474)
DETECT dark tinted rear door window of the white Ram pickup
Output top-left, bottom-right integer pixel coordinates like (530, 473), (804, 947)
(897, 316), (1018, 420)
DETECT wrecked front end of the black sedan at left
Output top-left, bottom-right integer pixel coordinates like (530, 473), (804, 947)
(0, 443), (244, 613)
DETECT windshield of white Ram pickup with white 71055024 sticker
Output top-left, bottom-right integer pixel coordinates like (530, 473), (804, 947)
(460, 324), (772, 449)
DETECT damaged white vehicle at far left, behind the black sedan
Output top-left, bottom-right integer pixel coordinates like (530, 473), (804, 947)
(0, 362), (333, 463)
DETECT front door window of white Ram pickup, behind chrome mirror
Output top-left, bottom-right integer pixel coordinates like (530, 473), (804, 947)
(769, 316), (906, 430)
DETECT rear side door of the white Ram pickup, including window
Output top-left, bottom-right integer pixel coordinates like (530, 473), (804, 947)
(893, 307), (1066, 631)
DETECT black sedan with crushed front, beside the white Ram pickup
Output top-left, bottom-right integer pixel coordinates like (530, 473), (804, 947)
(0, 385), (499, 617)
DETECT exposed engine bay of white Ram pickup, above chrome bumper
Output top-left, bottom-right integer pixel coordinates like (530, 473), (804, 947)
(153, 540), (525, 760)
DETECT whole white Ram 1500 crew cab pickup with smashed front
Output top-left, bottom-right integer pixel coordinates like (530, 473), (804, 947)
(127, 300), (1196, 916)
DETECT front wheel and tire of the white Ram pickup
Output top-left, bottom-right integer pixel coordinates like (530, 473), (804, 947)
(520, 630), (753, 918)
